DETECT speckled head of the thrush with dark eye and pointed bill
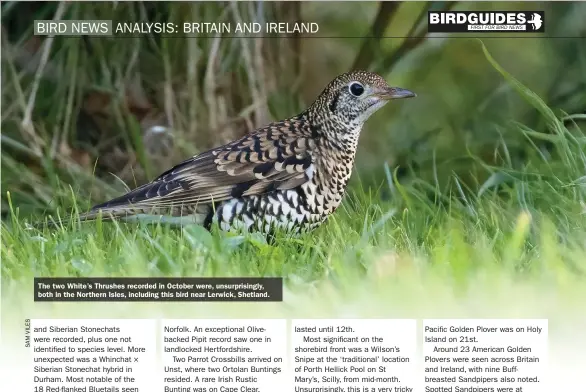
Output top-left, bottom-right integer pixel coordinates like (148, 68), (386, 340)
(313, 71), (415, 129)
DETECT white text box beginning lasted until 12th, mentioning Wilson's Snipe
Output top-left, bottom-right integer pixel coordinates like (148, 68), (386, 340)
(287, 319), (418, 392)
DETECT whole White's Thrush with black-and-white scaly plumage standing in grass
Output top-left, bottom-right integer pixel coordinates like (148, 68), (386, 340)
(80, 71), (415, 233)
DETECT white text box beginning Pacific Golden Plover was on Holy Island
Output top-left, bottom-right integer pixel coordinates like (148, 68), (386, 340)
(423, 319), (548, 392)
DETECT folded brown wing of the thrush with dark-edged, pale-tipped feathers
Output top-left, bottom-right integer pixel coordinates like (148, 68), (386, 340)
(93, 120), (314, 210)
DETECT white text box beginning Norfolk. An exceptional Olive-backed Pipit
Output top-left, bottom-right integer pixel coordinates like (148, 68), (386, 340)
(161, 319), (287, 392)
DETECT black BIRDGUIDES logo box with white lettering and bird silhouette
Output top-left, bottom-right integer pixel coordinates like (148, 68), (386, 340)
(427, 11), (545, 33)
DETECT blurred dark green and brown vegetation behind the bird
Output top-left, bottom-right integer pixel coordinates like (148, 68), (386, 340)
(1, 2), (586, 218)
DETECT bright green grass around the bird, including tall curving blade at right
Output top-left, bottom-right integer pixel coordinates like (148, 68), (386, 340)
(1, 20), (586, 303)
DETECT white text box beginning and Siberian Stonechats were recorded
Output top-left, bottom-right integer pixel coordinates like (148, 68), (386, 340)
(30, 319), (156, 392)
